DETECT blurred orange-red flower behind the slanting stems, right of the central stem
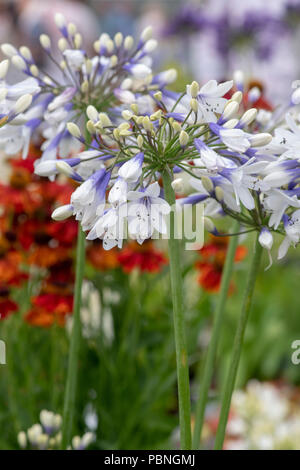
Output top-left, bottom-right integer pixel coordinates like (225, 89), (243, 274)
(196, 235), (247, 293)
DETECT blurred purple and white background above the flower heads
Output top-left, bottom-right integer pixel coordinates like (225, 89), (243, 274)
(0, 0), (300, 104)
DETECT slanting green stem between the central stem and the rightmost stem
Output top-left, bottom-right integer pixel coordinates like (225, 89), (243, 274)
(193, 220), (240, 449)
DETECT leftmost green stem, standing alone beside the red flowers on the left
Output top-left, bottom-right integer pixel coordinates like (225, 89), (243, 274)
(62, 224), (85, 449)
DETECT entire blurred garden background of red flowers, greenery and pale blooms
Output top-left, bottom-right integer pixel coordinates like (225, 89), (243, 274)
(0, 0), (300, 449)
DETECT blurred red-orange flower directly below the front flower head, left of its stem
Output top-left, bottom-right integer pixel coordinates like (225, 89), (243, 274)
(118, 240), (168, 273)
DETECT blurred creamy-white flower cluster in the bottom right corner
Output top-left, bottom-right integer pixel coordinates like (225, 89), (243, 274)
(225, 381), (300, 450)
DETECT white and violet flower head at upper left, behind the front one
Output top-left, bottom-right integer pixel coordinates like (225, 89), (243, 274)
(0, 13), (176, 166)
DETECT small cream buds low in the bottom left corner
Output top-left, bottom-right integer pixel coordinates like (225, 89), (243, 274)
(18, 410), (95, 450)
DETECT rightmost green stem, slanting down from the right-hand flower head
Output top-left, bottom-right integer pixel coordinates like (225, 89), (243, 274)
(215, 234), (262, 450)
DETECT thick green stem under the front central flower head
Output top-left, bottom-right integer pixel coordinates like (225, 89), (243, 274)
(162, 171), (192, 450)
